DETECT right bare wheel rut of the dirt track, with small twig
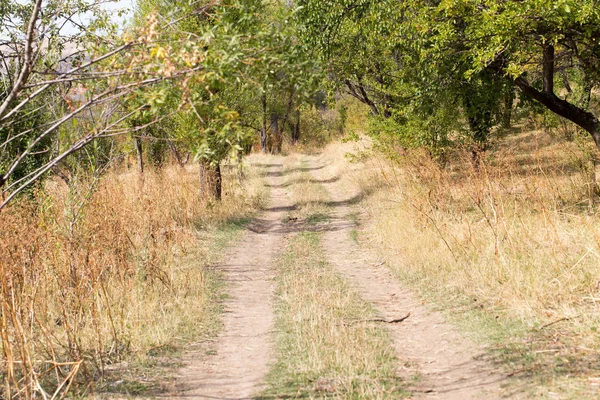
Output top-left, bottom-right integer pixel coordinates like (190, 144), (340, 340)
(307, 157), (503, 400)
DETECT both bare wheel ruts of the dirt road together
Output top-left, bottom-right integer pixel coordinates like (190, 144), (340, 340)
(166, 156), (503, 400)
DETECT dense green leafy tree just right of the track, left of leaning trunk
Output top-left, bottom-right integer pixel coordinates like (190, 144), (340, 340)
(300, 0), (505, 158)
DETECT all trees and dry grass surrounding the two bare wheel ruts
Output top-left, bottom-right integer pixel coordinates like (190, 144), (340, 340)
(0, 0), (600, 399)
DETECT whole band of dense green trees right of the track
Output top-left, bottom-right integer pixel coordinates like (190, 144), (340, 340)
(297, 0), (600, 163)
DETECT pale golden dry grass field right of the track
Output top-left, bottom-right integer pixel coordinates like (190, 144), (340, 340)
(318, 131), (600, 398)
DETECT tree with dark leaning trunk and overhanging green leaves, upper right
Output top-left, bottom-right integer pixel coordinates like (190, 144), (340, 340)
(408, 0), (600, 148)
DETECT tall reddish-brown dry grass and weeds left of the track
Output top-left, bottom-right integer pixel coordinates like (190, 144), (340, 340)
(0, 159), (264, 398)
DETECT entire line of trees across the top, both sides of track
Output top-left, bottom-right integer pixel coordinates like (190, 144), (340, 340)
(0, 0), (600, 206)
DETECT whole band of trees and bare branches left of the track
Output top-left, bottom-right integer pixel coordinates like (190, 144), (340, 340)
(0, 0), (322, 207)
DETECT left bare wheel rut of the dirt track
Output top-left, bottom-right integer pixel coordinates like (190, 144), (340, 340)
(171, 163), (290, 399)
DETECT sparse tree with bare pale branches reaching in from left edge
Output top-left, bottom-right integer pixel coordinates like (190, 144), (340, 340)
(0, 0), (211, 208)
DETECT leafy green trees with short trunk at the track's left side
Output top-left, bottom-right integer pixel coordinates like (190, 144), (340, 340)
(127, 0), (319, 198)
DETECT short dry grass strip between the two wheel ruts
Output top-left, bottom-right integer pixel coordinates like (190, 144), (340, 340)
(265, 232), (401, 399)
